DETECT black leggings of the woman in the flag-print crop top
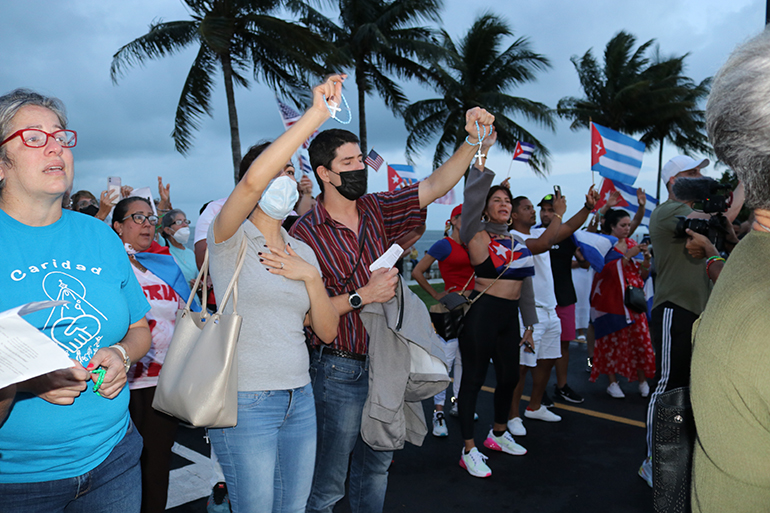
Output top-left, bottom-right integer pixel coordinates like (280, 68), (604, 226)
(457, 292), (521, 440)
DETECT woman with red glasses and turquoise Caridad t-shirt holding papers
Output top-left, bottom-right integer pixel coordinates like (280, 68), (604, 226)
(0, 89), (150, 512)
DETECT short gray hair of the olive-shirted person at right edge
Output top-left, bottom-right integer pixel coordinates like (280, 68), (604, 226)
(706, 30), (770, 209)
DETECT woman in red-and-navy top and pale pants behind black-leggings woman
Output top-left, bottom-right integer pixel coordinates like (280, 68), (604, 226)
(412, 205), (475, 436)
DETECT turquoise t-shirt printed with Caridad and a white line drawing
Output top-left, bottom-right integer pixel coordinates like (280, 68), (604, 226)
(0, 210), (150, 483)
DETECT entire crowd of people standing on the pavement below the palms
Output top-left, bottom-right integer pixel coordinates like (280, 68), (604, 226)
(0, 29), (770, 513)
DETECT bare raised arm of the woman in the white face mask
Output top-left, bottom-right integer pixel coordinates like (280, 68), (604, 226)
(213, 75), (345, 242)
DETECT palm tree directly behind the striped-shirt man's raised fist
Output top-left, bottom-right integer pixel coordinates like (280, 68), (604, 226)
(404, 13), (555, 174)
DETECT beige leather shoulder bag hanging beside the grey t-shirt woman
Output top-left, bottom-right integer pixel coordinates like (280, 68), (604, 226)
(152, 234), (246, 428)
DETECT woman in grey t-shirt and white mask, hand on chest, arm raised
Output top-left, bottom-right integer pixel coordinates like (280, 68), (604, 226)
(208, 75), (336, 513)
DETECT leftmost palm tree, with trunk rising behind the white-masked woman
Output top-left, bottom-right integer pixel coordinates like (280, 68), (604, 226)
(110, 0), (328, 181)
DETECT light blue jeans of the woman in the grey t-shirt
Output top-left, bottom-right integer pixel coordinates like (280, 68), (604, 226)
(209, 384), (316, 513)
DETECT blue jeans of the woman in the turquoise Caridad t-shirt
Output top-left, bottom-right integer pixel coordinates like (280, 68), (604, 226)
(0, 422), (142, 513)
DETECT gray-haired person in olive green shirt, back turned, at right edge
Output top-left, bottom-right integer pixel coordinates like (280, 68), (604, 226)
(690, 30), (770, 512)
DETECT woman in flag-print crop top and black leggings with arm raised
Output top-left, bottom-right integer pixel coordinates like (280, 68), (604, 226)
(458, 130), (537, 477)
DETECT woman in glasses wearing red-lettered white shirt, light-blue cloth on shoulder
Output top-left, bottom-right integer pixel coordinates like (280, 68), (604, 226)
(112, 197), (200, 513)
